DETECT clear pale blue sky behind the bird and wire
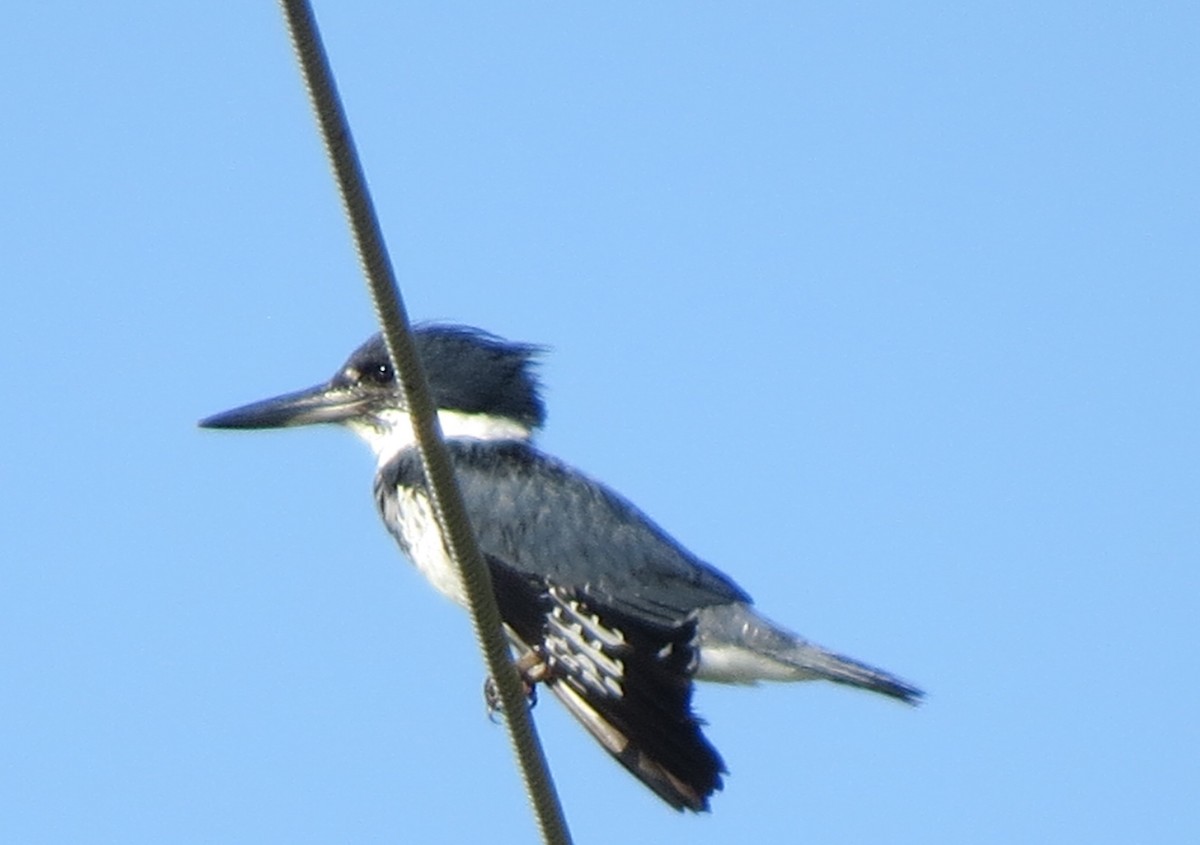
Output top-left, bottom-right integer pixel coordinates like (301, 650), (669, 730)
(0, 2), (1200, 845)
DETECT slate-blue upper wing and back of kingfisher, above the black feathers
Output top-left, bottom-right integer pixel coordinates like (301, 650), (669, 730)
(380, 439), (750, 624)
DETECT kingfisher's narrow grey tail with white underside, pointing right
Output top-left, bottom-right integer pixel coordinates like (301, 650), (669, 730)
(696, 603), (924, 705)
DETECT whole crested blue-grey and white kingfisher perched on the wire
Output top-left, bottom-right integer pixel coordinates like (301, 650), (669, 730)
(200, 324), (923, 811)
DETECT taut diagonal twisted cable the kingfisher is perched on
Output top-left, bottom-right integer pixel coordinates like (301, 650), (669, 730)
(280, 0), (571, 845)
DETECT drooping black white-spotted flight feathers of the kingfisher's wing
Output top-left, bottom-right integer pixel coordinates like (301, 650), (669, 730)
(487, 557), (725, 811)
